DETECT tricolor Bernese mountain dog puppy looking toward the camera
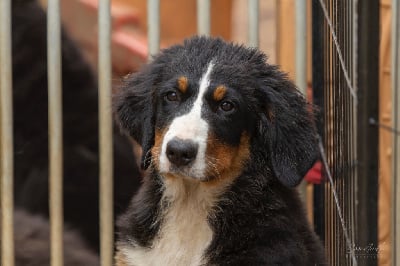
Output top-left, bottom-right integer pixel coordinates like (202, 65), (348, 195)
(114, 37), (324, 266)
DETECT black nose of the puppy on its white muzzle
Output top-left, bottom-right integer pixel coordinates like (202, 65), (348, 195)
(166, 138), (199, 166)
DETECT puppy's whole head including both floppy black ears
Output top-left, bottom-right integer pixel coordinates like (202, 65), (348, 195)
(114, 37), (317, 186)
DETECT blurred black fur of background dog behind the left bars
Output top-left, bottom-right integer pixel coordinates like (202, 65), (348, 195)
(12, 0), (140, 249)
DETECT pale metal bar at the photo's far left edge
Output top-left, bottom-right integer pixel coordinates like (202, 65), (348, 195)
(0, 0), (14, 266)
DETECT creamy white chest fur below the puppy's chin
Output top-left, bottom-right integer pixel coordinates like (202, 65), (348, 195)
(120, 178), (225, 266)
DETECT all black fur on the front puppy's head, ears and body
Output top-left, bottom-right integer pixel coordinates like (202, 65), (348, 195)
(114, 37), (324, 265)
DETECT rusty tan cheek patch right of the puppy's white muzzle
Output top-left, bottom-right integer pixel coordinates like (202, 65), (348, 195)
(207, 133), (250, 186)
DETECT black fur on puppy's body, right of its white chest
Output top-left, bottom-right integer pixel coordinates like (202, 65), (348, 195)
(206, 169), (324, 265)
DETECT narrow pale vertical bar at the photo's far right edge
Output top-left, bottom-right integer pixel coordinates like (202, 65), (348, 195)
(391, 0), (400, 265)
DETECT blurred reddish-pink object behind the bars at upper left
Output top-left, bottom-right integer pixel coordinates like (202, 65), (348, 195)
(61, 0), (148, 76)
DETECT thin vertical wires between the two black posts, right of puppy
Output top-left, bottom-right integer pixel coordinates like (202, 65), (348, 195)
(320, 0), (357, 265)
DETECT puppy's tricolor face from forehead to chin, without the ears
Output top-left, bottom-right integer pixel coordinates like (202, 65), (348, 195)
(151, 60), (254, 181)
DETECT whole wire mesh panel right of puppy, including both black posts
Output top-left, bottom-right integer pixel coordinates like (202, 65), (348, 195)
(313, 0), (379, 265)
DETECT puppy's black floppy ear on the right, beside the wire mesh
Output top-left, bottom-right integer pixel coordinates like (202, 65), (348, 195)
(258, 69), (319, 187)
